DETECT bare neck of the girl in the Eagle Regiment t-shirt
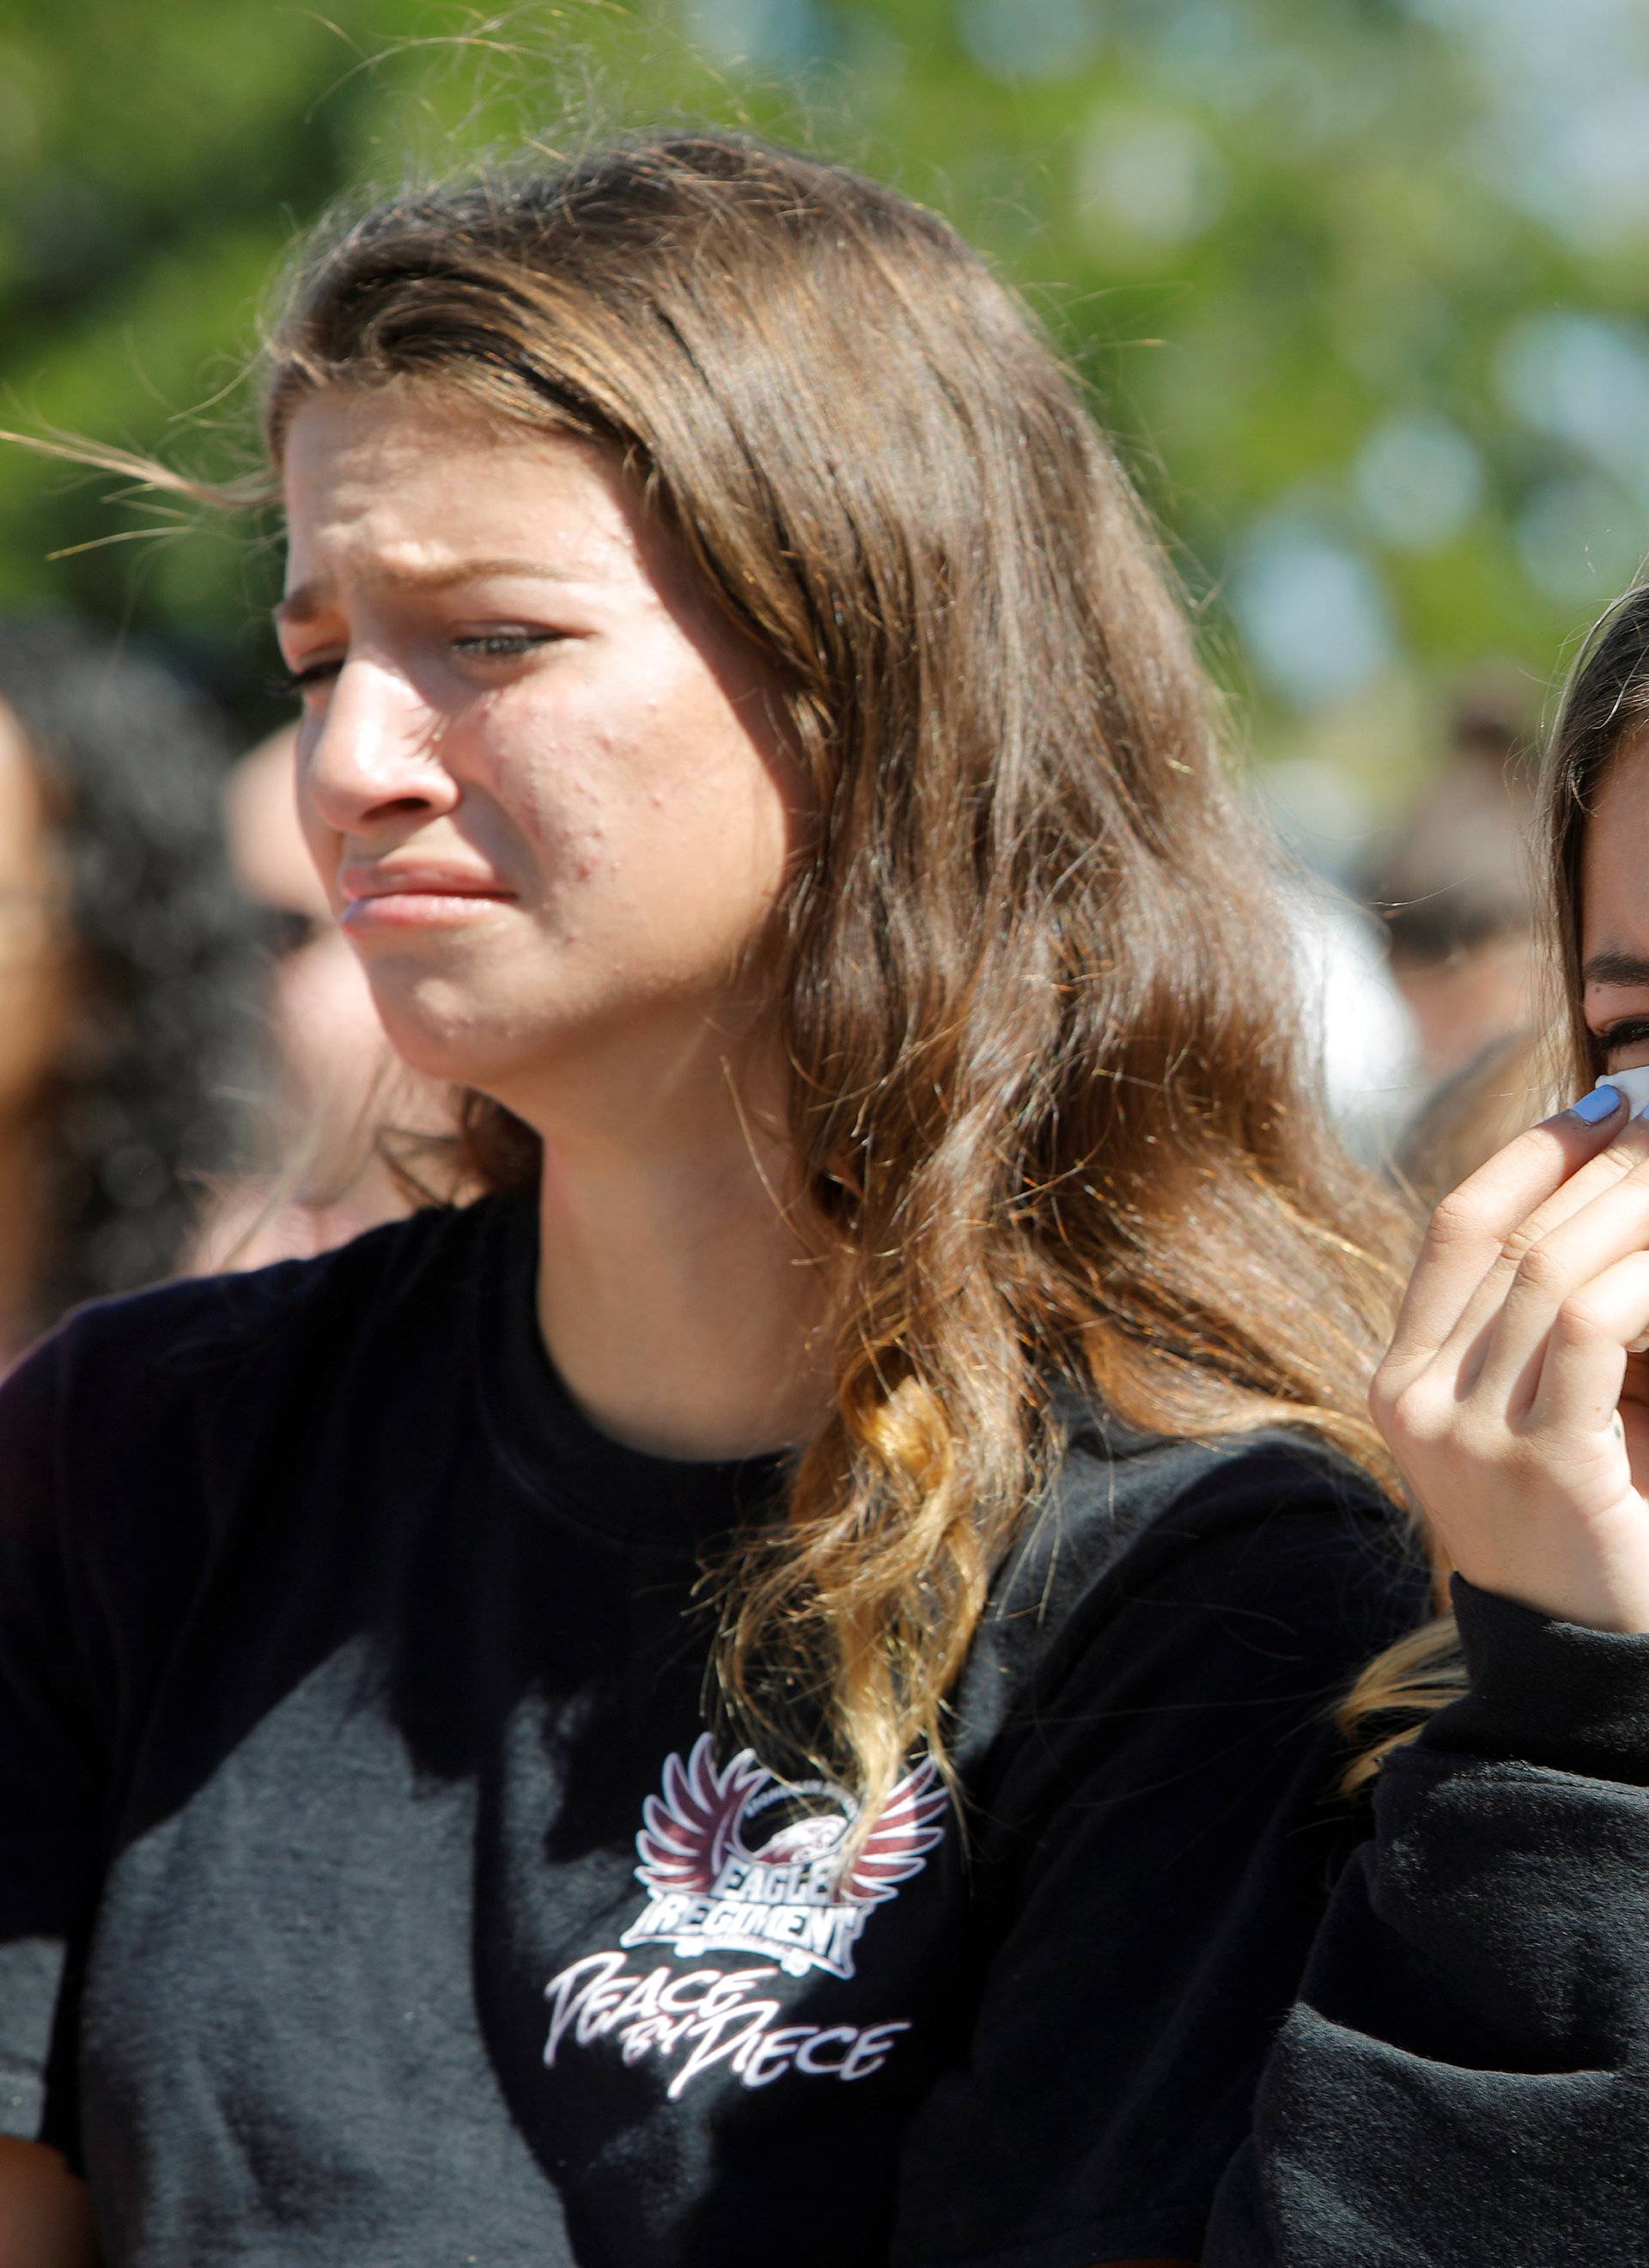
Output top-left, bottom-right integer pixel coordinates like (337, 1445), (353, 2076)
(538, 1057), (831, 1459)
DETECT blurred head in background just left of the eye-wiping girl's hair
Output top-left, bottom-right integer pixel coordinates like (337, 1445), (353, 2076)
(1368, 687), (1536, 1080)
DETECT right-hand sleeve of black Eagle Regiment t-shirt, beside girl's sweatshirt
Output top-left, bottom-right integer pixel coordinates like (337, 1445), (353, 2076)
(891, 1454), (1427, 2268)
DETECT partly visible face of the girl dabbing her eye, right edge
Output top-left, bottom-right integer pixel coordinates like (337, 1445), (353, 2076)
(1581, 741), (1649, 1070)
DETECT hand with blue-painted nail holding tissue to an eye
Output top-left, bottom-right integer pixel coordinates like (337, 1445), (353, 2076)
(1370, 1095), (1649, 1631)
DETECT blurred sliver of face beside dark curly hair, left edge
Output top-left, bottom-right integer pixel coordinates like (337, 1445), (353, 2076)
(0, 701), (68, 1111)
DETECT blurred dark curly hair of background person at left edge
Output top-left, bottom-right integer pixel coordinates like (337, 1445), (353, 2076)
(0, 617), (259, 1329)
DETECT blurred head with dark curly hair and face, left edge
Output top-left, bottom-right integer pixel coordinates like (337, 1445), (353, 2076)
(0, 617), (254, 1350)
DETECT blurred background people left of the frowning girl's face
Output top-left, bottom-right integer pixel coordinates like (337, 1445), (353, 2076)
(0, 639), (442, 1370)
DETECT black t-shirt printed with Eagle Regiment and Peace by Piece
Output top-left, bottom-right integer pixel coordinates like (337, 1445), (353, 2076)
(0, 1200), (1427, 2268)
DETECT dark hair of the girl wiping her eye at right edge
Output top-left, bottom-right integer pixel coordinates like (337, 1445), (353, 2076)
(1540, 582), (1649, 1087)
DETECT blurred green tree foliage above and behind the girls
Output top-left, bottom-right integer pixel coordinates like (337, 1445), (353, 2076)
(0, 0), (1649, 791)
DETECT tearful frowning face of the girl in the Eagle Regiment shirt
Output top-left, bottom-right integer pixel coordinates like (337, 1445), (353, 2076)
(279, 390), (799, 1119)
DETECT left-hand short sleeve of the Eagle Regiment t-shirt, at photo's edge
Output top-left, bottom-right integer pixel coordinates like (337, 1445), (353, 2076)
(0, 1343), (104, 2159)
